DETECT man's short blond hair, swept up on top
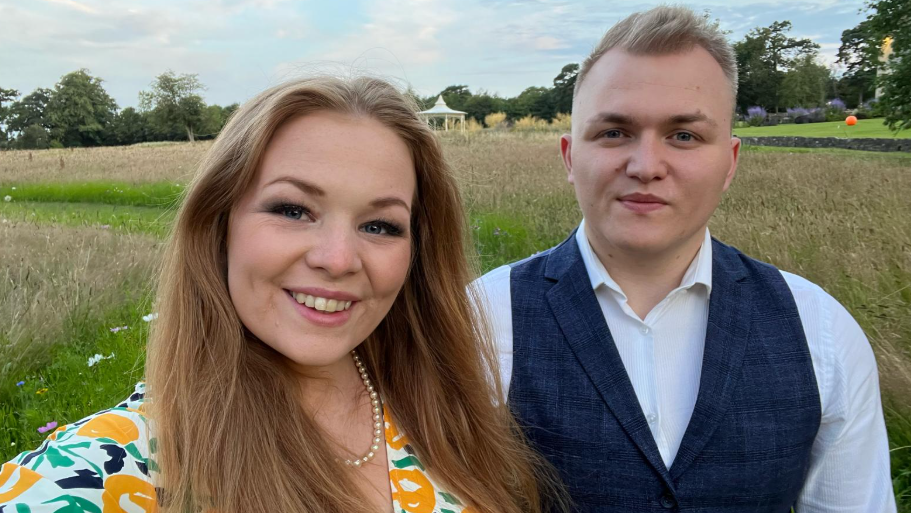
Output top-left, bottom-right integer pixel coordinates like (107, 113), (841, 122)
(573, 5), (737, 103)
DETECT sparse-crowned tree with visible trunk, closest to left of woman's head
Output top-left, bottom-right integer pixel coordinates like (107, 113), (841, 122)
(139, 70), (206, 142)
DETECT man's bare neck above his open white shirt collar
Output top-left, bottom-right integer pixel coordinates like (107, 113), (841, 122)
(586, 226), (705, 319)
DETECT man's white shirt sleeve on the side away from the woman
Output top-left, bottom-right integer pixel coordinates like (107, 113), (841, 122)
(782, 273), (896, 513)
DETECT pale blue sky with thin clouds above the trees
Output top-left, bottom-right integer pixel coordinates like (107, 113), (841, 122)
(0, 0), (866, 108)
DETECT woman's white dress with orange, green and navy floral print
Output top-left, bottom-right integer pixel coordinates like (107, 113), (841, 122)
(0, 383), (473, 513)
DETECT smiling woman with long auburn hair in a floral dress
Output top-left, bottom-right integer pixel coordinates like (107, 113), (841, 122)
(0, 78), (553, 513)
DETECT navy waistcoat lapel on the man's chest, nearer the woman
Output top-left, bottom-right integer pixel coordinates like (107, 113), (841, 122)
(545, 236), (673, 489)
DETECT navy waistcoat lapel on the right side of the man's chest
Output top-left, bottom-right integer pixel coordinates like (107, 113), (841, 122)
(671, 239), (753, 479)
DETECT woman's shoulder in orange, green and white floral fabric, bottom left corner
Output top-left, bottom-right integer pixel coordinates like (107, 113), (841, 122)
(0, 383), (157, 512)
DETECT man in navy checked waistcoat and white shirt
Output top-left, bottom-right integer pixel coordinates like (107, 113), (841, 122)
(478, 7), (895, 513)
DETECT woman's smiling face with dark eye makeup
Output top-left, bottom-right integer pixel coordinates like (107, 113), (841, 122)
(227, 112), (415, 368)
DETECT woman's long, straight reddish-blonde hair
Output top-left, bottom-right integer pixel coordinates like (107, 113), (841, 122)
(147, 77), (556, 513)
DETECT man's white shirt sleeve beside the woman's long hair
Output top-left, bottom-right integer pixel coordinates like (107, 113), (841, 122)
(471, 265), (513, 401)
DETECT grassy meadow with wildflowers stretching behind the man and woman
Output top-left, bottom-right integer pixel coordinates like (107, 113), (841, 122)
(0, 133), (911, 513)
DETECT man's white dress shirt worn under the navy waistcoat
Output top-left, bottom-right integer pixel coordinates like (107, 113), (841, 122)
(475, 220), (896, 513)
